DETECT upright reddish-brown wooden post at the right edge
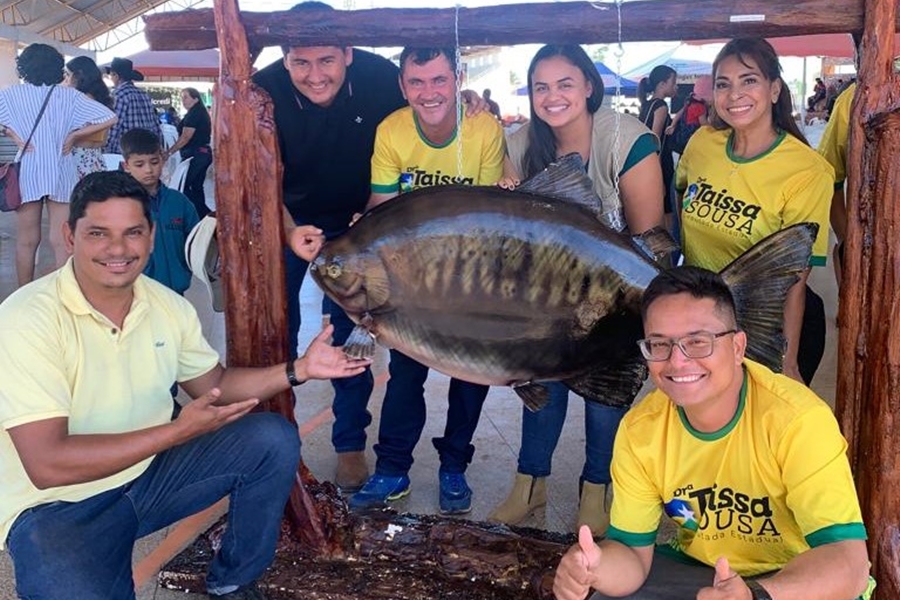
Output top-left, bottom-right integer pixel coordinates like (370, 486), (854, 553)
(836, 0), (900, 600)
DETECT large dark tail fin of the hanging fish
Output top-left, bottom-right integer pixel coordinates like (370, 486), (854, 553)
(720, 223), (819, 373)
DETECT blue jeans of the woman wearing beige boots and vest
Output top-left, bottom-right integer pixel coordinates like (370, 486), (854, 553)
(518, 382), (628, 483)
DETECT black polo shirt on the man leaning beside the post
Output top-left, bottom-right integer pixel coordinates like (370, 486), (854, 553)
(253, 49), (406, 233)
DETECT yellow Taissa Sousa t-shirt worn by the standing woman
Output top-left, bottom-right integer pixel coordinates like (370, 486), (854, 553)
(675, 127), (834, 271)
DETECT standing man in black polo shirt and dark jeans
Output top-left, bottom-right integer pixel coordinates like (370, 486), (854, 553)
(253, 2), (406, 493)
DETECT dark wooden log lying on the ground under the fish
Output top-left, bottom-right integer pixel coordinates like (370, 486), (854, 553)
(160, 483), (574, 600)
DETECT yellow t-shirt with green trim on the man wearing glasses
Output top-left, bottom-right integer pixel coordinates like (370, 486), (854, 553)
(608, 360), (866, 577)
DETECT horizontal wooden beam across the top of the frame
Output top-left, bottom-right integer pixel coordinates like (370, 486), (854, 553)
(144, 0), (896, 50)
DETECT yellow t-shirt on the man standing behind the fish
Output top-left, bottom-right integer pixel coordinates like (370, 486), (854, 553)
(372, 106), (506, 194)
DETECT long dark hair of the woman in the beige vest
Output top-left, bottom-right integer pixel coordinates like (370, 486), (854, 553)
(522, 44), (603, 178)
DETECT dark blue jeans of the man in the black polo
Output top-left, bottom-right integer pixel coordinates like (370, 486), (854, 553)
(284, 241), (375, 453)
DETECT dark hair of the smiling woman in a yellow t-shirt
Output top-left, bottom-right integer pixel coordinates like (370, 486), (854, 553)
(709, 38), (809, 146)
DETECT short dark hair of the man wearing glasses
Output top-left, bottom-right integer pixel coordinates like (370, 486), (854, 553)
(641, 266), (737, 325)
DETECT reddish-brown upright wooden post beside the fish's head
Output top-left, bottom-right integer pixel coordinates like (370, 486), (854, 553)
(213, 0), (334, 554)
